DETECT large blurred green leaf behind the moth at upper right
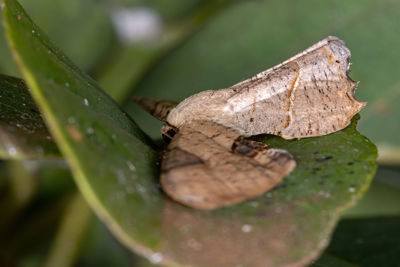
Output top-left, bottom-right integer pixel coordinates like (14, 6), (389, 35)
(128, 0), (400, 163)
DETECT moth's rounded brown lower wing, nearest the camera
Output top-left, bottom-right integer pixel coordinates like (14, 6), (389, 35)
(160, 121), (295, 210)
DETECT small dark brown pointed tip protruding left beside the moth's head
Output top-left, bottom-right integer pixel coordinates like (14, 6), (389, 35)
(132, 96), (177, 122)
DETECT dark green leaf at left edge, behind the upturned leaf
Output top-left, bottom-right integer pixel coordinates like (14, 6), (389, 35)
(0, 74), (59, 159)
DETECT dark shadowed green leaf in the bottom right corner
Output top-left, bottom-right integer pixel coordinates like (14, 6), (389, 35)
(314, 217), (400, 266)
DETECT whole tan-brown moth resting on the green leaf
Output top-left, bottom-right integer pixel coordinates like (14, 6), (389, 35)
(136, 36), (366, 210)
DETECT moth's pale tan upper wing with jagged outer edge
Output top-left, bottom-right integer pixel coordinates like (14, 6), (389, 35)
(167, 36), (365, 139)
